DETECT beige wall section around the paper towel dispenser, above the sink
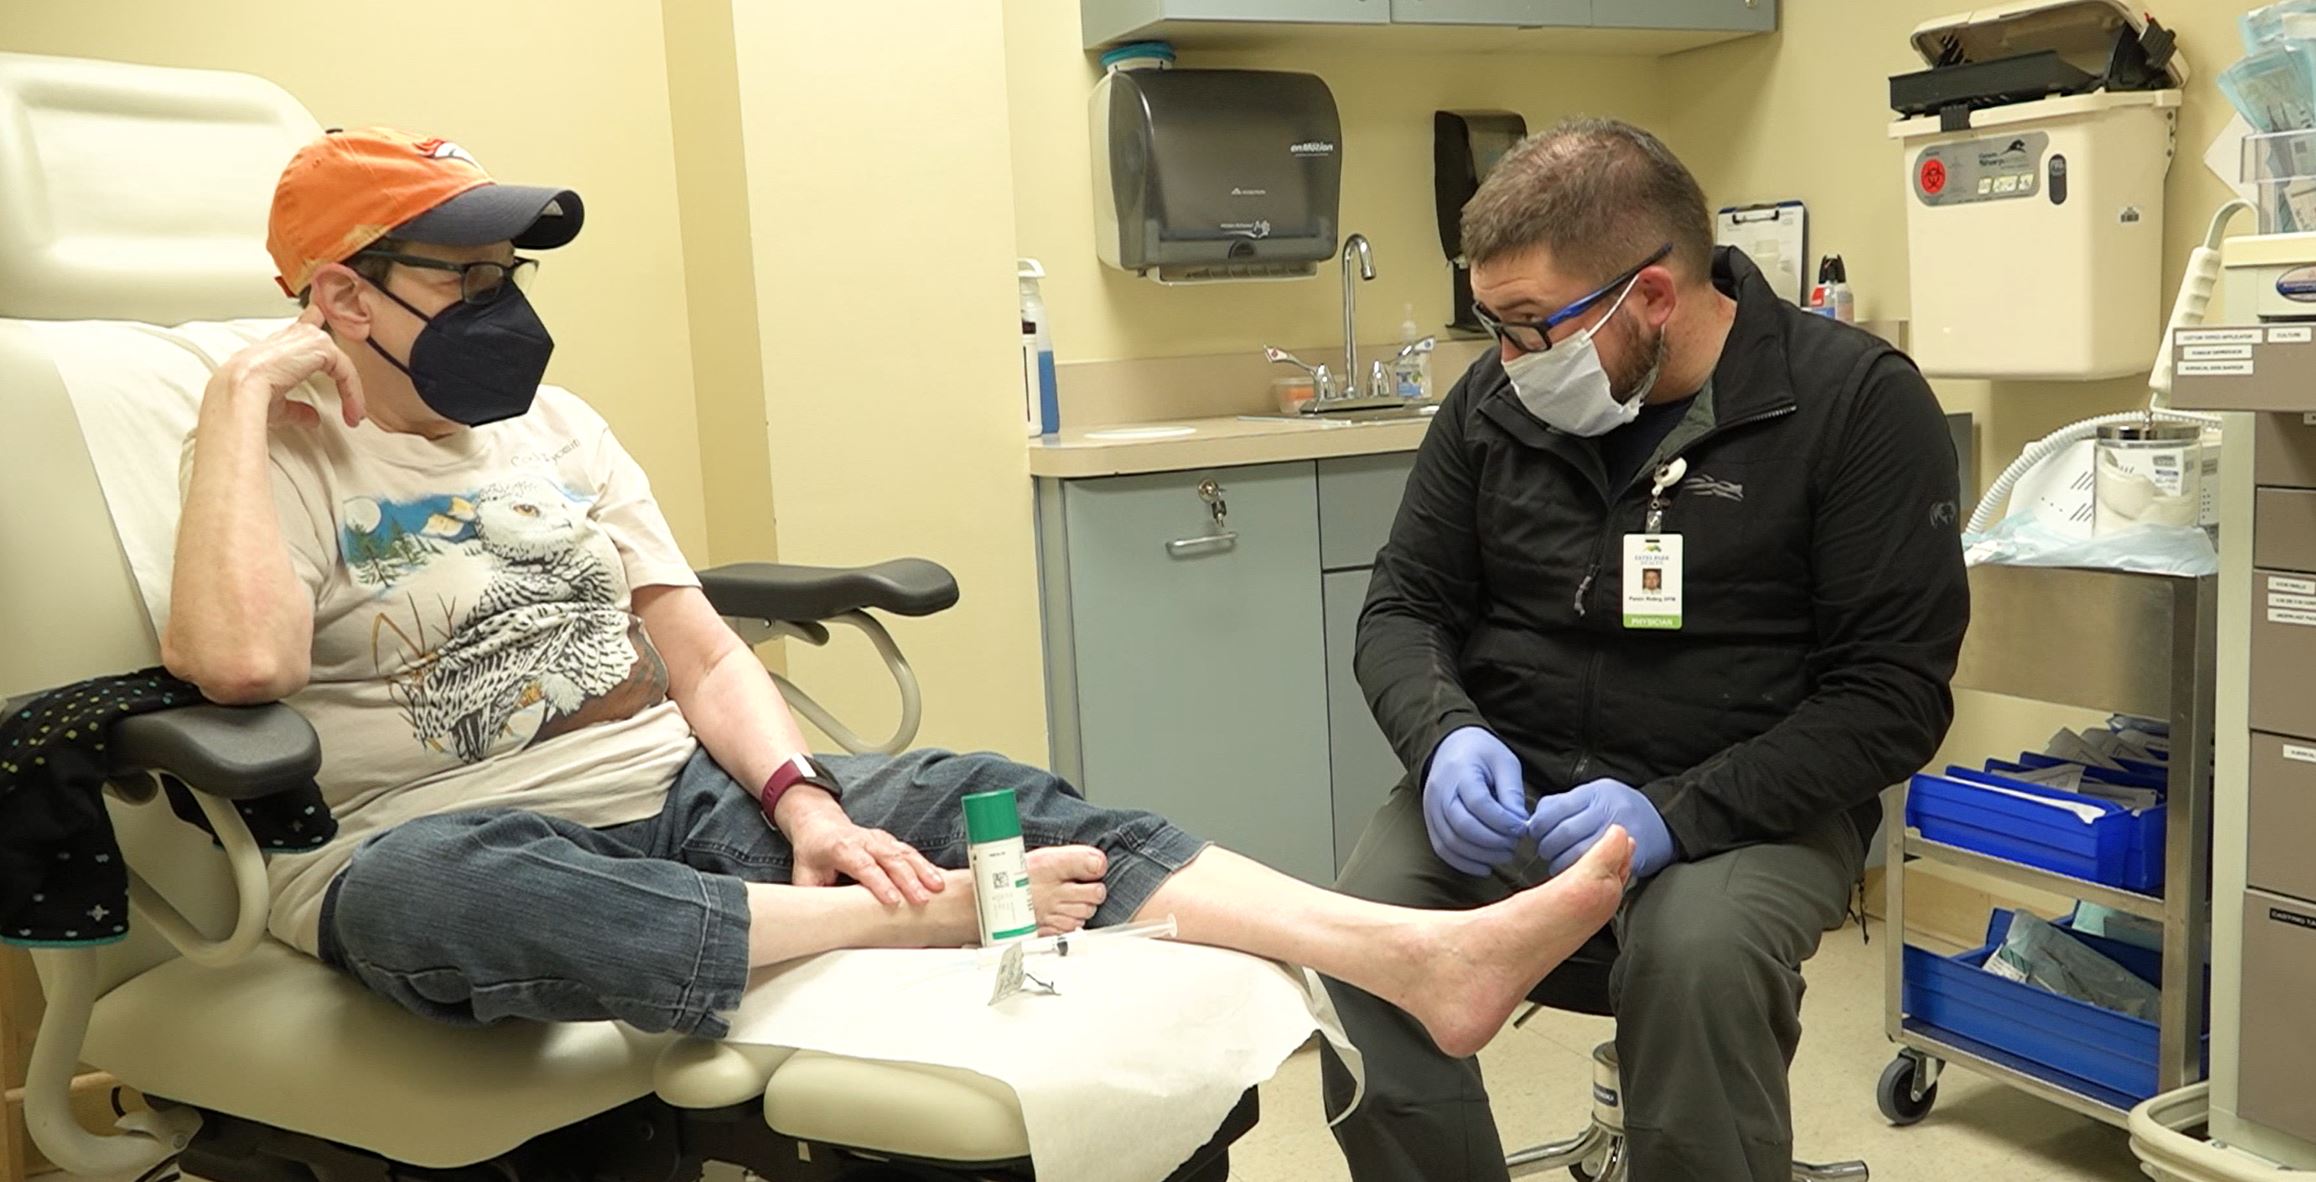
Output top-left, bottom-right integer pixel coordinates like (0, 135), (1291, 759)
(1005, 0), (1665, 364)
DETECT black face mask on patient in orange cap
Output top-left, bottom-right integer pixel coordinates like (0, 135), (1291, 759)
(371, 283), (556, 426)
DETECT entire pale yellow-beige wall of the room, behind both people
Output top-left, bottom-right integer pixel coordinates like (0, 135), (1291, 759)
(22, 0), (2242, 774)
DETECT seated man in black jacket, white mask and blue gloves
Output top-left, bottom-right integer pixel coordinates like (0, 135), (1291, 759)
(1327, 121), (1969, 1182)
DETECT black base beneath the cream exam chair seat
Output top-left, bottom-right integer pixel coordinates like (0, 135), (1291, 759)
(162, 1089), (1260, 1182)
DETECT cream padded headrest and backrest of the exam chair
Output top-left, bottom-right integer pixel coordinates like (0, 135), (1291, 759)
(0, 53), (317, 990)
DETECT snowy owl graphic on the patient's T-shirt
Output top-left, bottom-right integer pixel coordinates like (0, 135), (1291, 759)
(338, 475), (667, 763)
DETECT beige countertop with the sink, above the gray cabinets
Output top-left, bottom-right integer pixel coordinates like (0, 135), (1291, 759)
(1028, 415), (1431, 480)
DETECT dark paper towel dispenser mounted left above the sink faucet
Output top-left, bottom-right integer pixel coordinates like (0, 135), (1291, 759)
(1091, 67), (1343, 283)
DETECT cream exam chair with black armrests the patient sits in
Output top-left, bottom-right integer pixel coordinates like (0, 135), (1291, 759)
(0, 53), (1255, 1182)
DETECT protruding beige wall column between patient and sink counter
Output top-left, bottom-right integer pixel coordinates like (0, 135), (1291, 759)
(722, 0), (1045, 763)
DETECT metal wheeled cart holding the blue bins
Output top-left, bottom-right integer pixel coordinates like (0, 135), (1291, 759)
(1876, 566), (2219, 1126)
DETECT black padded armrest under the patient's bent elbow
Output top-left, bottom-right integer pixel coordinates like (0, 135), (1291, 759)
(107, 705), (322, 802)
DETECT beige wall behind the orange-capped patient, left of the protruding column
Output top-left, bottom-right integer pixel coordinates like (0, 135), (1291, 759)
(0, 0), (706, 561)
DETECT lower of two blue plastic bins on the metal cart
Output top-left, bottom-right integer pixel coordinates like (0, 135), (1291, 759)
(1904, 911), (2204, 1108)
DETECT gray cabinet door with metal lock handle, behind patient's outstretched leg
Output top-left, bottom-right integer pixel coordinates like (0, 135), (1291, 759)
(1040, 464), (1334, 883)
